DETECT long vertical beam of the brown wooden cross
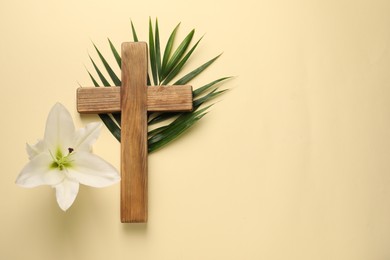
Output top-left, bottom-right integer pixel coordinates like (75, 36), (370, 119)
(121, 42), (148, 223)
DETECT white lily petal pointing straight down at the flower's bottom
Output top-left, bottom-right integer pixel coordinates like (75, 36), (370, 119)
(55, 179), (80, 211)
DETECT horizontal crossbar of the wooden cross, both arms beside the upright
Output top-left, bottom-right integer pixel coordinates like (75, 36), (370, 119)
(77, 85), (192, 114)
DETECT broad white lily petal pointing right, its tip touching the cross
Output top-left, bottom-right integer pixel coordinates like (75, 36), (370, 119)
(66, 151), (120, 188)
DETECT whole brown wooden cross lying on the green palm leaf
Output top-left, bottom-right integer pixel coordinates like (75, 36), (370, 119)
(77, 42), (192, 223)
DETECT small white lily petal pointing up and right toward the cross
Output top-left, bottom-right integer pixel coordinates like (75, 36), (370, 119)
(73, 122), (102, 152)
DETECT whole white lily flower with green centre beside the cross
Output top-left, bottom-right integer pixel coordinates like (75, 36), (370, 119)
(16, 103), (120, 211)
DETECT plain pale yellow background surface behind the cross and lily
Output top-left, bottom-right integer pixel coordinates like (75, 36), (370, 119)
(0, 0), (390, 260)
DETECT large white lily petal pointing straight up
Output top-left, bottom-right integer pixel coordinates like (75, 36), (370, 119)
(44, 103), (75, 154)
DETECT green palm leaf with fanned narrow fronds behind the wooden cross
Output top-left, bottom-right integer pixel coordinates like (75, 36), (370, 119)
(87, 18), (231, 152)
